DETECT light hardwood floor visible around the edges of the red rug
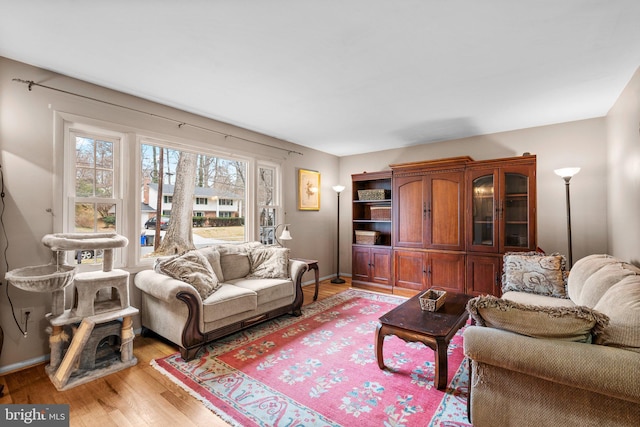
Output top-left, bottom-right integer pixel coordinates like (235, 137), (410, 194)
(0, 278), (351, 427)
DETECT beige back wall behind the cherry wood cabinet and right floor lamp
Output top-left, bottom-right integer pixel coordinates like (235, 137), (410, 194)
(340, 118), (607, 266)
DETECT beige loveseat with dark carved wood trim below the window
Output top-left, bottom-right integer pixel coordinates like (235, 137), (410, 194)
(134, 242), (307, 360)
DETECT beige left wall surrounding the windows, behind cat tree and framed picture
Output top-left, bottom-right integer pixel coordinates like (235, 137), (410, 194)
(0, 57), (339, 373)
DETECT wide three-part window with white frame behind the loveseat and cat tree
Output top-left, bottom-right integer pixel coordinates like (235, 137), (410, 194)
(59, 112), (280, 270)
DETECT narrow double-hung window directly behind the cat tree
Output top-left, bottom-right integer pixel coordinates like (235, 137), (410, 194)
(65, 130), (121, 264)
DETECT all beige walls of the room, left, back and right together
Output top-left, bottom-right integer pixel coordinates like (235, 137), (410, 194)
(0, 57), (640, 373)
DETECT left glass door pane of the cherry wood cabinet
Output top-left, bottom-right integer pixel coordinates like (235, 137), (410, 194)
(471, 173), (497, 252)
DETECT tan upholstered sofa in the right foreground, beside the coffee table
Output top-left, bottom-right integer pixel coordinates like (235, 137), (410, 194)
(464, 255), (640, 427)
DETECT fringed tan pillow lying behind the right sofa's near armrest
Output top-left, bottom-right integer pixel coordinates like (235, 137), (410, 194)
(467, 295), (609, 342)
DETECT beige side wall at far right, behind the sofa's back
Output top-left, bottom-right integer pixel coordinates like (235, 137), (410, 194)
(607, 68), (640, 265)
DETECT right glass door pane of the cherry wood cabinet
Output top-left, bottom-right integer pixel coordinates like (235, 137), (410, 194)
(502, 173), (531, 249)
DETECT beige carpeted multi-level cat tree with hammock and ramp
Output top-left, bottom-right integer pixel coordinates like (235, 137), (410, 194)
(6, 233), (138, 390)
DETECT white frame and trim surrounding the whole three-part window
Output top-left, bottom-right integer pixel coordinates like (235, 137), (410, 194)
(52, 110), (284, 271)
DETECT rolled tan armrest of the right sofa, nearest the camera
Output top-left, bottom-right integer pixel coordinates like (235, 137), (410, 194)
(464, 326), (640, 403)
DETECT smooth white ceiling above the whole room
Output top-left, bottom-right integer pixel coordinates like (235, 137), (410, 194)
(0, 0), (640, 156)
